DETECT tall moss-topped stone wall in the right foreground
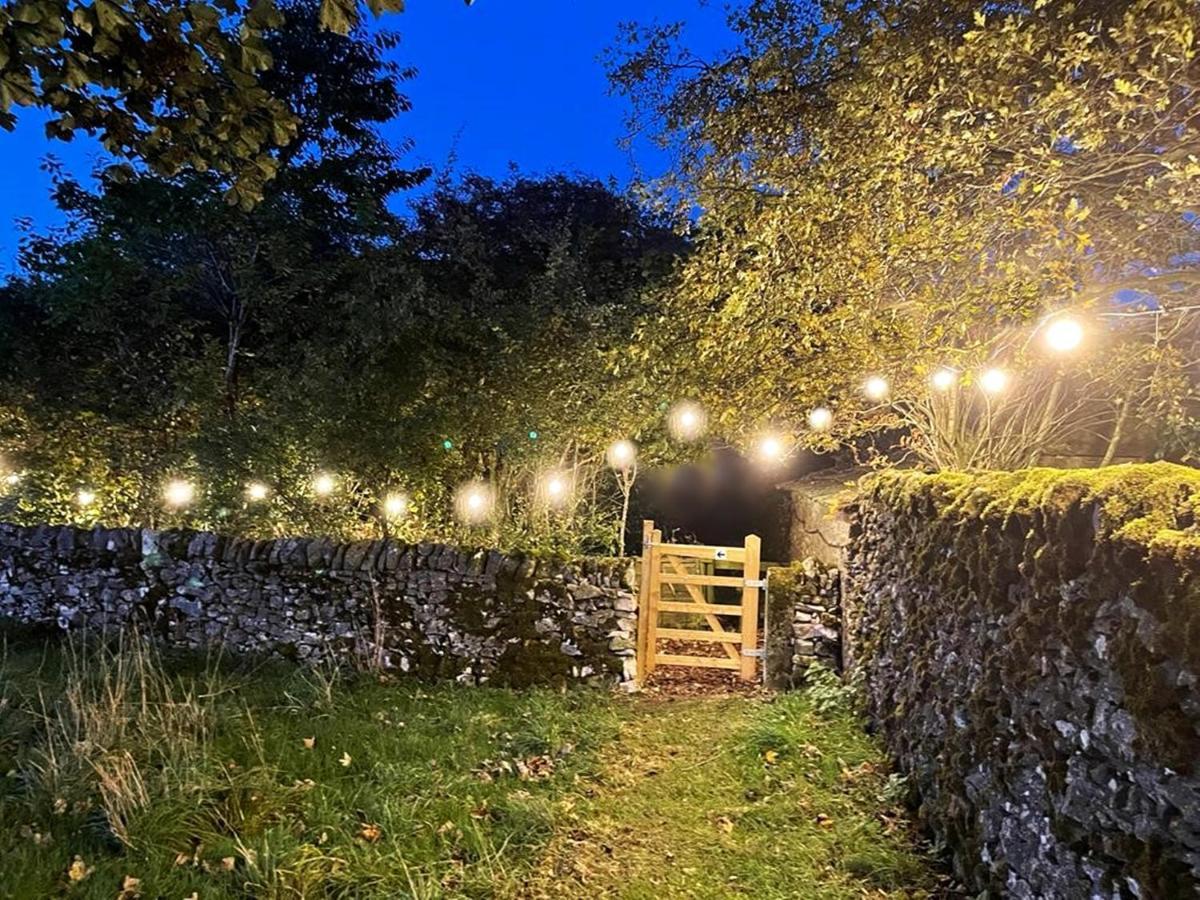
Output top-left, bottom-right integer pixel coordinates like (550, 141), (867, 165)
(844, 463), (1200, 898)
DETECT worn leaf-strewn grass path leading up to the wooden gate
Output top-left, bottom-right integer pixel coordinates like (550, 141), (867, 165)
(522, 696), (938, 900)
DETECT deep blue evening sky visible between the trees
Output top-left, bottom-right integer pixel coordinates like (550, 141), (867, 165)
(0, 0), (730, 272)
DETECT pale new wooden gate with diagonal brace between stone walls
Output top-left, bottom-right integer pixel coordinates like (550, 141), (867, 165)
(637, 520), (764, 682)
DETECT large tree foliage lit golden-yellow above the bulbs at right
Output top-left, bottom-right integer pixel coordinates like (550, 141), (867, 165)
(610, 0), (1200, 464)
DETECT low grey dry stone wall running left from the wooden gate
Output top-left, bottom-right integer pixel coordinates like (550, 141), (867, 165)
(0, 524), (636, 685)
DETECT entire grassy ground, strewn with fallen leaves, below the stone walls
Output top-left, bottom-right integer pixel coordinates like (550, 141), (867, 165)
(0, 641), (940, 900)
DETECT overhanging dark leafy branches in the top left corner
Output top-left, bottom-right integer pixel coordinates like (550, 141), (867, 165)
(0, 0), (469, 208)
